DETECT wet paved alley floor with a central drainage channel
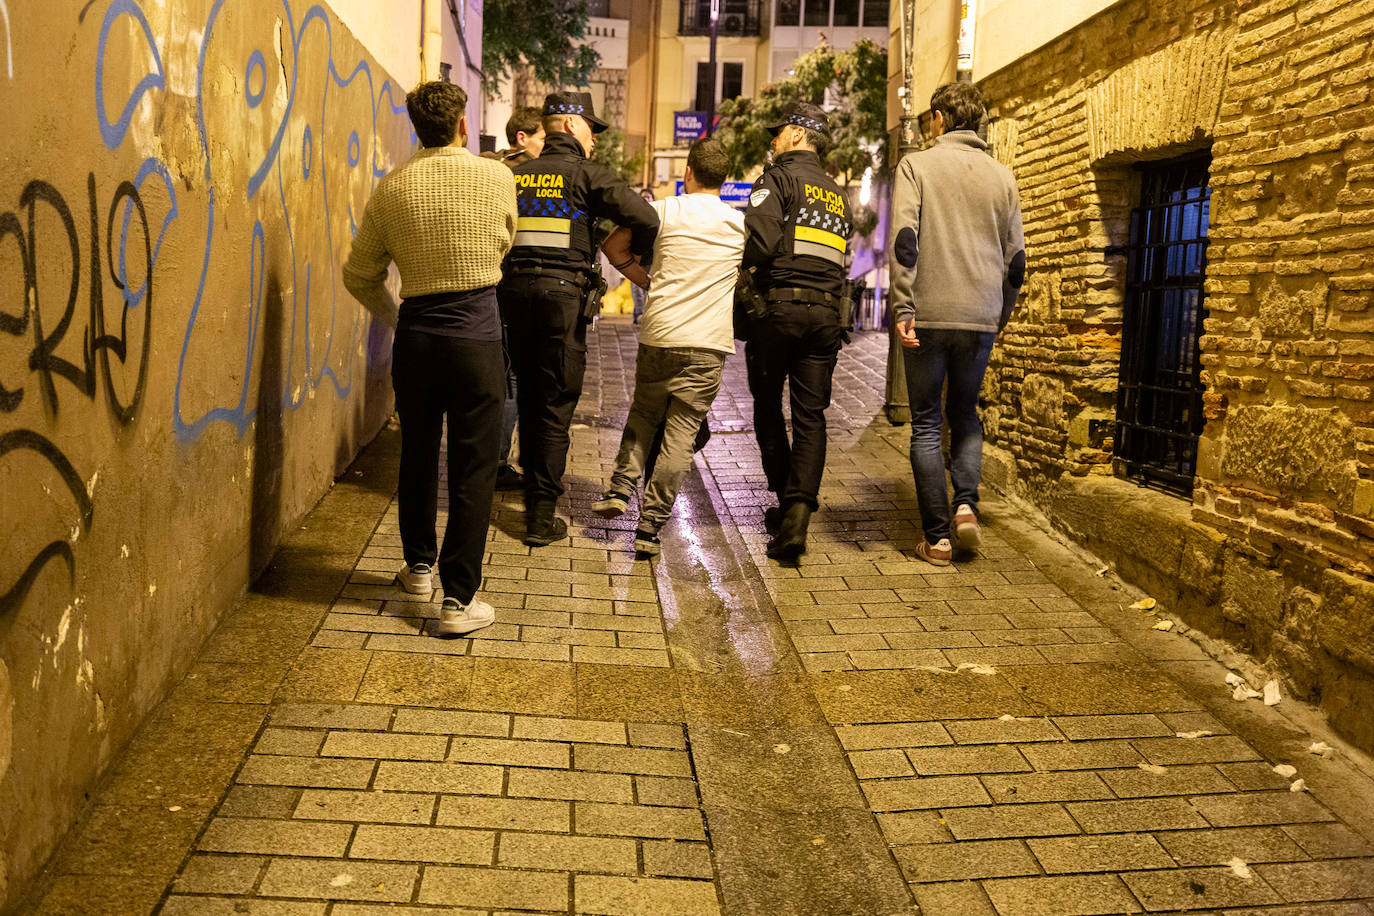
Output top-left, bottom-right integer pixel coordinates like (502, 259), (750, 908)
(26, 319), (1374, 916)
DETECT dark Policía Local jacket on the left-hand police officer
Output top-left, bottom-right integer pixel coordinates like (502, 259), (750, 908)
(507, 133), (658, 273)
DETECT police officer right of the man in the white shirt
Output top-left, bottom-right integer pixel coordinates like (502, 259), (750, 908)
(743, 103), (853, 560)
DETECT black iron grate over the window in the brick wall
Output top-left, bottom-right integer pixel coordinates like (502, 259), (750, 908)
(1114, 155), (1212, 496)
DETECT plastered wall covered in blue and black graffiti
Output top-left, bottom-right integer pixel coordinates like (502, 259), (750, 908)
(0, 0), (414, 908)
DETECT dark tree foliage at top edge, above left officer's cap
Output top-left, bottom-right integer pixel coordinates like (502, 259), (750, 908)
(482, 0), (600, 93)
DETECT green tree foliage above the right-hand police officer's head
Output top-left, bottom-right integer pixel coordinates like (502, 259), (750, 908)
(716, 38), (888, 235)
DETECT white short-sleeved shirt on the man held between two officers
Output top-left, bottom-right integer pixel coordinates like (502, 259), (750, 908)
(639, 194), (745, 353)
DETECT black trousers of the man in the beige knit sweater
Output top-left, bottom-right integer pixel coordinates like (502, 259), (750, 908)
(392, 330), (506, 604)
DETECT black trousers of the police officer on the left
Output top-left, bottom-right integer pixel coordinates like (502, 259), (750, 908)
(496, 276), (587, 512)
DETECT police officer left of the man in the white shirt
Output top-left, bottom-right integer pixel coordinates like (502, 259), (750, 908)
(497, 92), (658, 547)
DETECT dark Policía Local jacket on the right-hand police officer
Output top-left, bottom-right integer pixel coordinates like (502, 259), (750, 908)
(743, 150), (853, 295)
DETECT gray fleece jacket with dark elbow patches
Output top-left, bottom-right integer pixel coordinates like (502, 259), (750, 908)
(890, 130), (1025, 331)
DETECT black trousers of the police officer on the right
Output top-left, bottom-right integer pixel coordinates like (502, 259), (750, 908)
(745, 302), (844, 509)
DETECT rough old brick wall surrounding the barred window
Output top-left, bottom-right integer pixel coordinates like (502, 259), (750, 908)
(982, 0), (1374, 747)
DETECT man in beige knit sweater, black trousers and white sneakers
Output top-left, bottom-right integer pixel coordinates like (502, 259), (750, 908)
(344, 82), (515, 637)
